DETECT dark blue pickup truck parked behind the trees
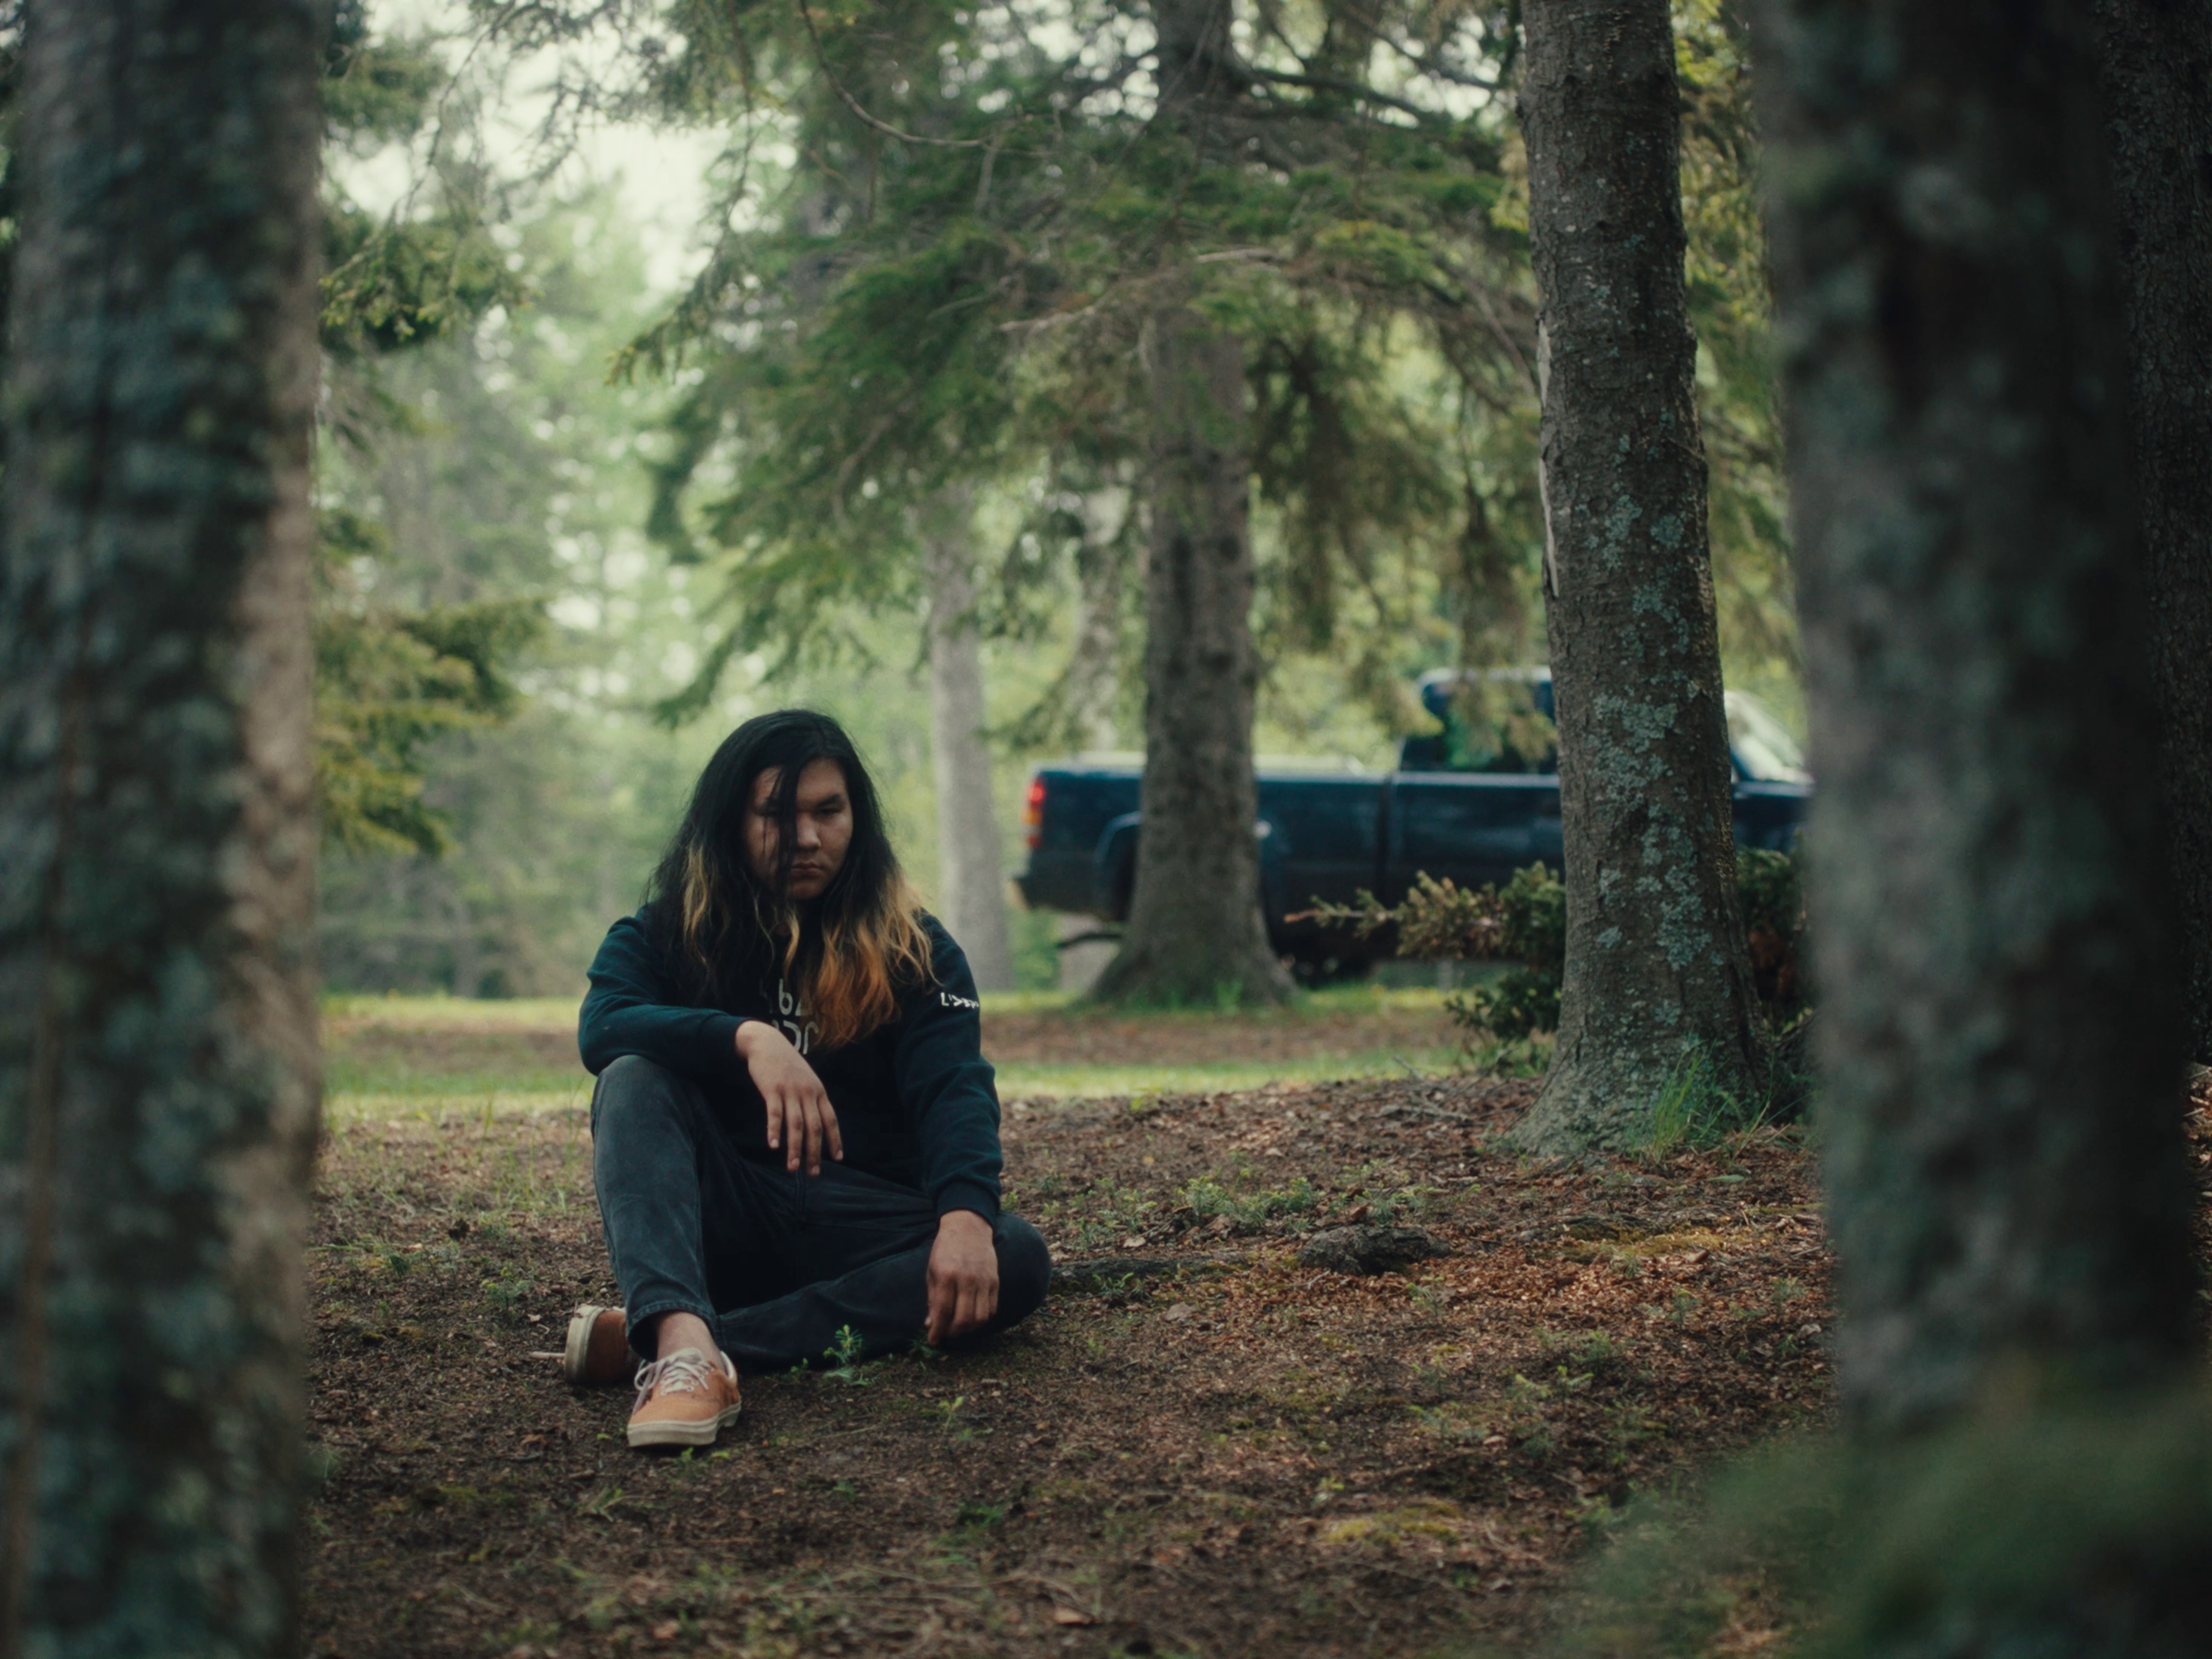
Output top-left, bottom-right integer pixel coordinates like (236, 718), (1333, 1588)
(1016, 668), (1812, 978)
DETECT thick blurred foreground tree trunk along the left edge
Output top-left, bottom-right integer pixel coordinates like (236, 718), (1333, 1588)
(0, 0), (325, 1654)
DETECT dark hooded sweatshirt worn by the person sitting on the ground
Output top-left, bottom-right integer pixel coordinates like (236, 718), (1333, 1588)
(577, 909), (1000, 1219)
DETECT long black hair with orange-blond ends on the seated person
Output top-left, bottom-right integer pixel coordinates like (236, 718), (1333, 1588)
(646, 708), (929, 1049)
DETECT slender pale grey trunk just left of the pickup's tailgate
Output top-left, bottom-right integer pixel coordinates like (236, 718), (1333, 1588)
(922, 489), (1013, 991)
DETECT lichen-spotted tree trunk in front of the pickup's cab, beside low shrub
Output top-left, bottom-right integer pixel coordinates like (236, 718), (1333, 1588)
(1520, 0), (1767, 1153)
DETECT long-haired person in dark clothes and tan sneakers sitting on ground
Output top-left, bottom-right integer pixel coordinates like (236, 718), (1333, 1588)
(564, 710), (1051, 1447)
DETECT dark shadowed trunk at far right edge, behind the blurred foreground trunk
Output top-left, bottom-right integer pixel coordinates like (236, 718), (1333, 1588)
(2094, 0), (2212, 1062)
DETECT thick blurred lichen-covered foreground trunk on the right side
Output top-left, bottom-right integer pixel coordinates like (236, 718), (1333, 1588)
(1756, 0), (2195, 1435)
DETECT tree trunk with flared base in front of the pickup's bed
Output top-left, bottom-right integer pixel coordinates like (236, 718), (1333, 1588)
(1097, 307), (1290, 1002)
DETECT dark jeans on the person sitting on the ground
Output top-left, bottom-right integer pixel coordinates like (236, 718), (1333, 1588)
(591, 1055), (1053, 1371)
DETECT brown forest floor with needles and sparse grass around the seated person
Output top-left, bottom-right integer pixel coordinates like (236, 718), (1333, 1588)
(307, 1004), (1827, 1659)
